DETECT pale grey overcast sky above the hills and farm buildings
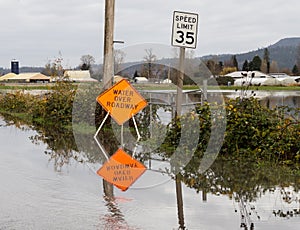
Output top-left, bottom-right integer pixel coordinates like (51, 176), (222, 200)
(0, 0), (300, 67)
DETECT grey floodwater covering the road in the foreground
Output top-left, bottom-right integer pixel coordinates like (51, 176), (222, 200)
(0, 118), (300, 230)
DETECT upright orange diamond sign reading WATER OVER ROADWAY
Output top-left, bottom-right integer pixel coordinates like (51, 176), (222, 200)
(97, 79), (147, 125)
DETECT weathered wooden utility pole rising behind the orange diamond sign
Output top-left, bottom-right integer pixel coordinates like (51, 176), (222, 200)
(103, 0), (115, 89)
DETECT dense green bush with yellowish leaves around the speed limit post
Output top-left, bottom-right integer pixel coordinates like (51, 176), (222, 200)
(161, 98), (300, 164)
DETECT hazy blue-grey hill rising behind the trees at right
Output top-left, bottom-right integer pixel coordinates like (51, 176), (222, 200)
(201, 37), (300, 69)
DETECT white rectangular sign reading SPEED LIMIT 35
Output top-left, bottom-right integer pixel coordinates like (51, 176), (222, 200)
(172, 11), (198, 49)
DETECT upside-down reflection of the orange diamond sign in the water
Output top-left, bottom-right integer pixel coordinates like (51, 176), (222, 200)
(97, 148), (146, 191)
